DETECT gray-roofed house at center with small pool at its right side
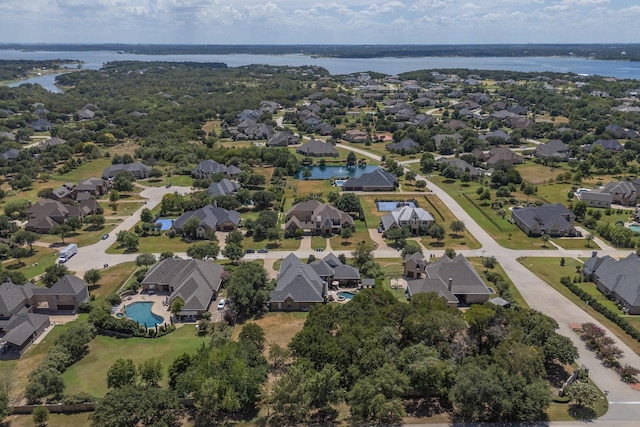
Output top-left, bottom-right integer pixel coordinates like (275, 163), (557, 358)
(269, 253), (360, 311)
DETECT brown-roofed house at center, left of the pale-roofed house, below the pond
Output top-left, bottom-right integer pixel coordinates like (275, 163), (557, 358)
(284, 200), (354, 235)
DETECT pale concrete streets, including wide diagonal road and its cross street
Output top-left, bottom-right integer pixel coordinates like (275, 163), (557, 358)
(60, 144), (640, 427)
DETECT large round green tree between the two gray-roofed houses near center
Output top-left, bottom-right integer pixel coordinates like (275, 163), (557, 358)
(227, 263), (273, 316)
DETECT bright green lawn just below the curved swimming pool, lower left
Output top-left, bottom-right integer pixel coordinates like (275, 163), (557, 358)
(62, 324), (210, 397)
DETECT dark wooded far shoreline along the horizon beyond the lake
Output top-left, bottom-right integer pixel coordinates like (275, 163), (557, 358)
(0, 43), (640, 61)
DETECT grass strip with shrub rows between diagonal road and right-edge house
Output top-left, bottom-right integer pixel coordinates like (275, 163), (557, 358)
(519, 257), (640, 354)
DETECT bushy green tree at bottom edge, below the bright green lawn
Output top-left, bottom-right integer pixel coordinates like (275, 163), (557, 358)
(91, 386), (183, 427)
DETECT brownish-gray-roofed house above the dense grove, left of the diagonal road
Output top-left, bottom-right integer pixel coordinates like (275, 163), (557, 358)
(405, 254), (491, 307)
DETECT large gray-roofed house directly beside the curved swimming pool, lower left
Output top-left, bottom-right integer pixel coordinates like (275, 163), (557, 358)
(140, 258), (224, 320)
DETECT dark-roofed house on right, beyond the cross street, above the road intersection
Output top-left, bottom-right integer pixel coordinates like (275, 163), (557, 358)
(511, 203), (580, 237)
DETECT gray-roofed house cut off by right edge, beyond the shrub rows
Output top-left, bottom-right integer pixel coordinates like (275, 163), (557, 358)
(582, 253), (640, 314)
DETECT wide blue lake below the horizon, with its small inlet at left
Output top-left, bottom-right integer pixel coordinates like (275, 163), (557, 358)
(0, 49), (640, 91)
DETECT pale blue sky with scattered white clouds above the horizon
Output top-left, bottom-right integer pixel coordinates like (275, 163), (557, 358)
(0, 0), (640, 44)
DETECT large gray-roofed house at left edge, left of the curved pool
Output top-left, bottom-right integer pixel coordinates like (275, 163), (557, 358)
(0, 275), (89, 357)
